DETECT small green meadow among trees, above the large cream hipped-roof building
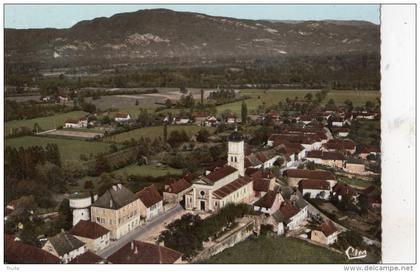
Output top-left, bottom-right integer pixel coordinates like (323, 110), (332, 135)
(112, 164), (182, 177)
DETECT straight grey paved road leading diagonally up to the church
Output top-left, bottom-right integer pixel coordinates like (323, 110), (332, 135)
(96, 205), (182, 258)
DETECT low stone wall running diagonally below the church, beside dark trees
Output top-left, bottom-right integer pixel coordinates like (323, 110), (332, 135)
(192, 217), (258, 263)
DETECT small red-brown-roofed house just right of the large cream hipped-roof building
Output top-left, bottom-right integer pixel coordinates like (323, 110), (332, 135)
(136, 184), (163, 221)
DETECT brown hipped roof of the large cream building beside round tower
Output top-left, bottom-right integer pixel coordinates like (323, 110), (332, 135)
(92, 184), (137, 210)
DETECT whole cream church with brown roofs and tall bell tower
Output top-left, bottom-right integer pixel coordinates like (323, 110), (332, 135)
(185, 131), (254, 211)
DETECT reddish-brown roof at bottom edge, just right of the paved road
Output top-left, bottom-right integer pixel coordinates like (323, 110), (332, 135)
(108, 241), (182, 264)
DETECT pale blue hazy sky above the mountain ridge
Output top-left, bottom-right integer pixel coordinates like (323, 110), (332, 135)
(5, 4), (380, 28)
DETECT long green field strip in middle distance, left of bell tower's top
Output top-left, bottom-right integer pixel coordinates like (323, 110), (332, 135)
(105, 125), (215, 143)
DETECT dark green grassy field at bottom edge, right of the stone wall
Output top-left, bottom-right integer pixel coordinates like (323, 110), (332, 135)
(206, 236), (356, 264)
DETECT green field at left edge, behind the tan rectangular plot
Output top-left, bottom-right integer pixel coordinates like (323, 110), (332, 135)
(4, 111), (87, 135)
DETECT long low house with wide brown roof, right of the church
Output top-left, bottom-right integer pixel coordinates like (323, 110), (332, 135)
(283, 169), (337, 188)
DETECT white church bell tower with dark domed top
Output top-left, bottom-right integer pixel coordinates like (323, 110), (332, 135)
(228, 129), (245, 176)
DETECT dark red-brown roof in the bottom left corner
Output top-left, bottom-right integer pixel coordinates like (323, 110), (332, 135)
(4, 234), (60, 264)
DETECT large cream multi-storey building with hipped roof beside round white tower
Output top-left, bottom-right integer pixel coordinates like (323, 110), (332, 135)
(91, 184), (141, 240)
